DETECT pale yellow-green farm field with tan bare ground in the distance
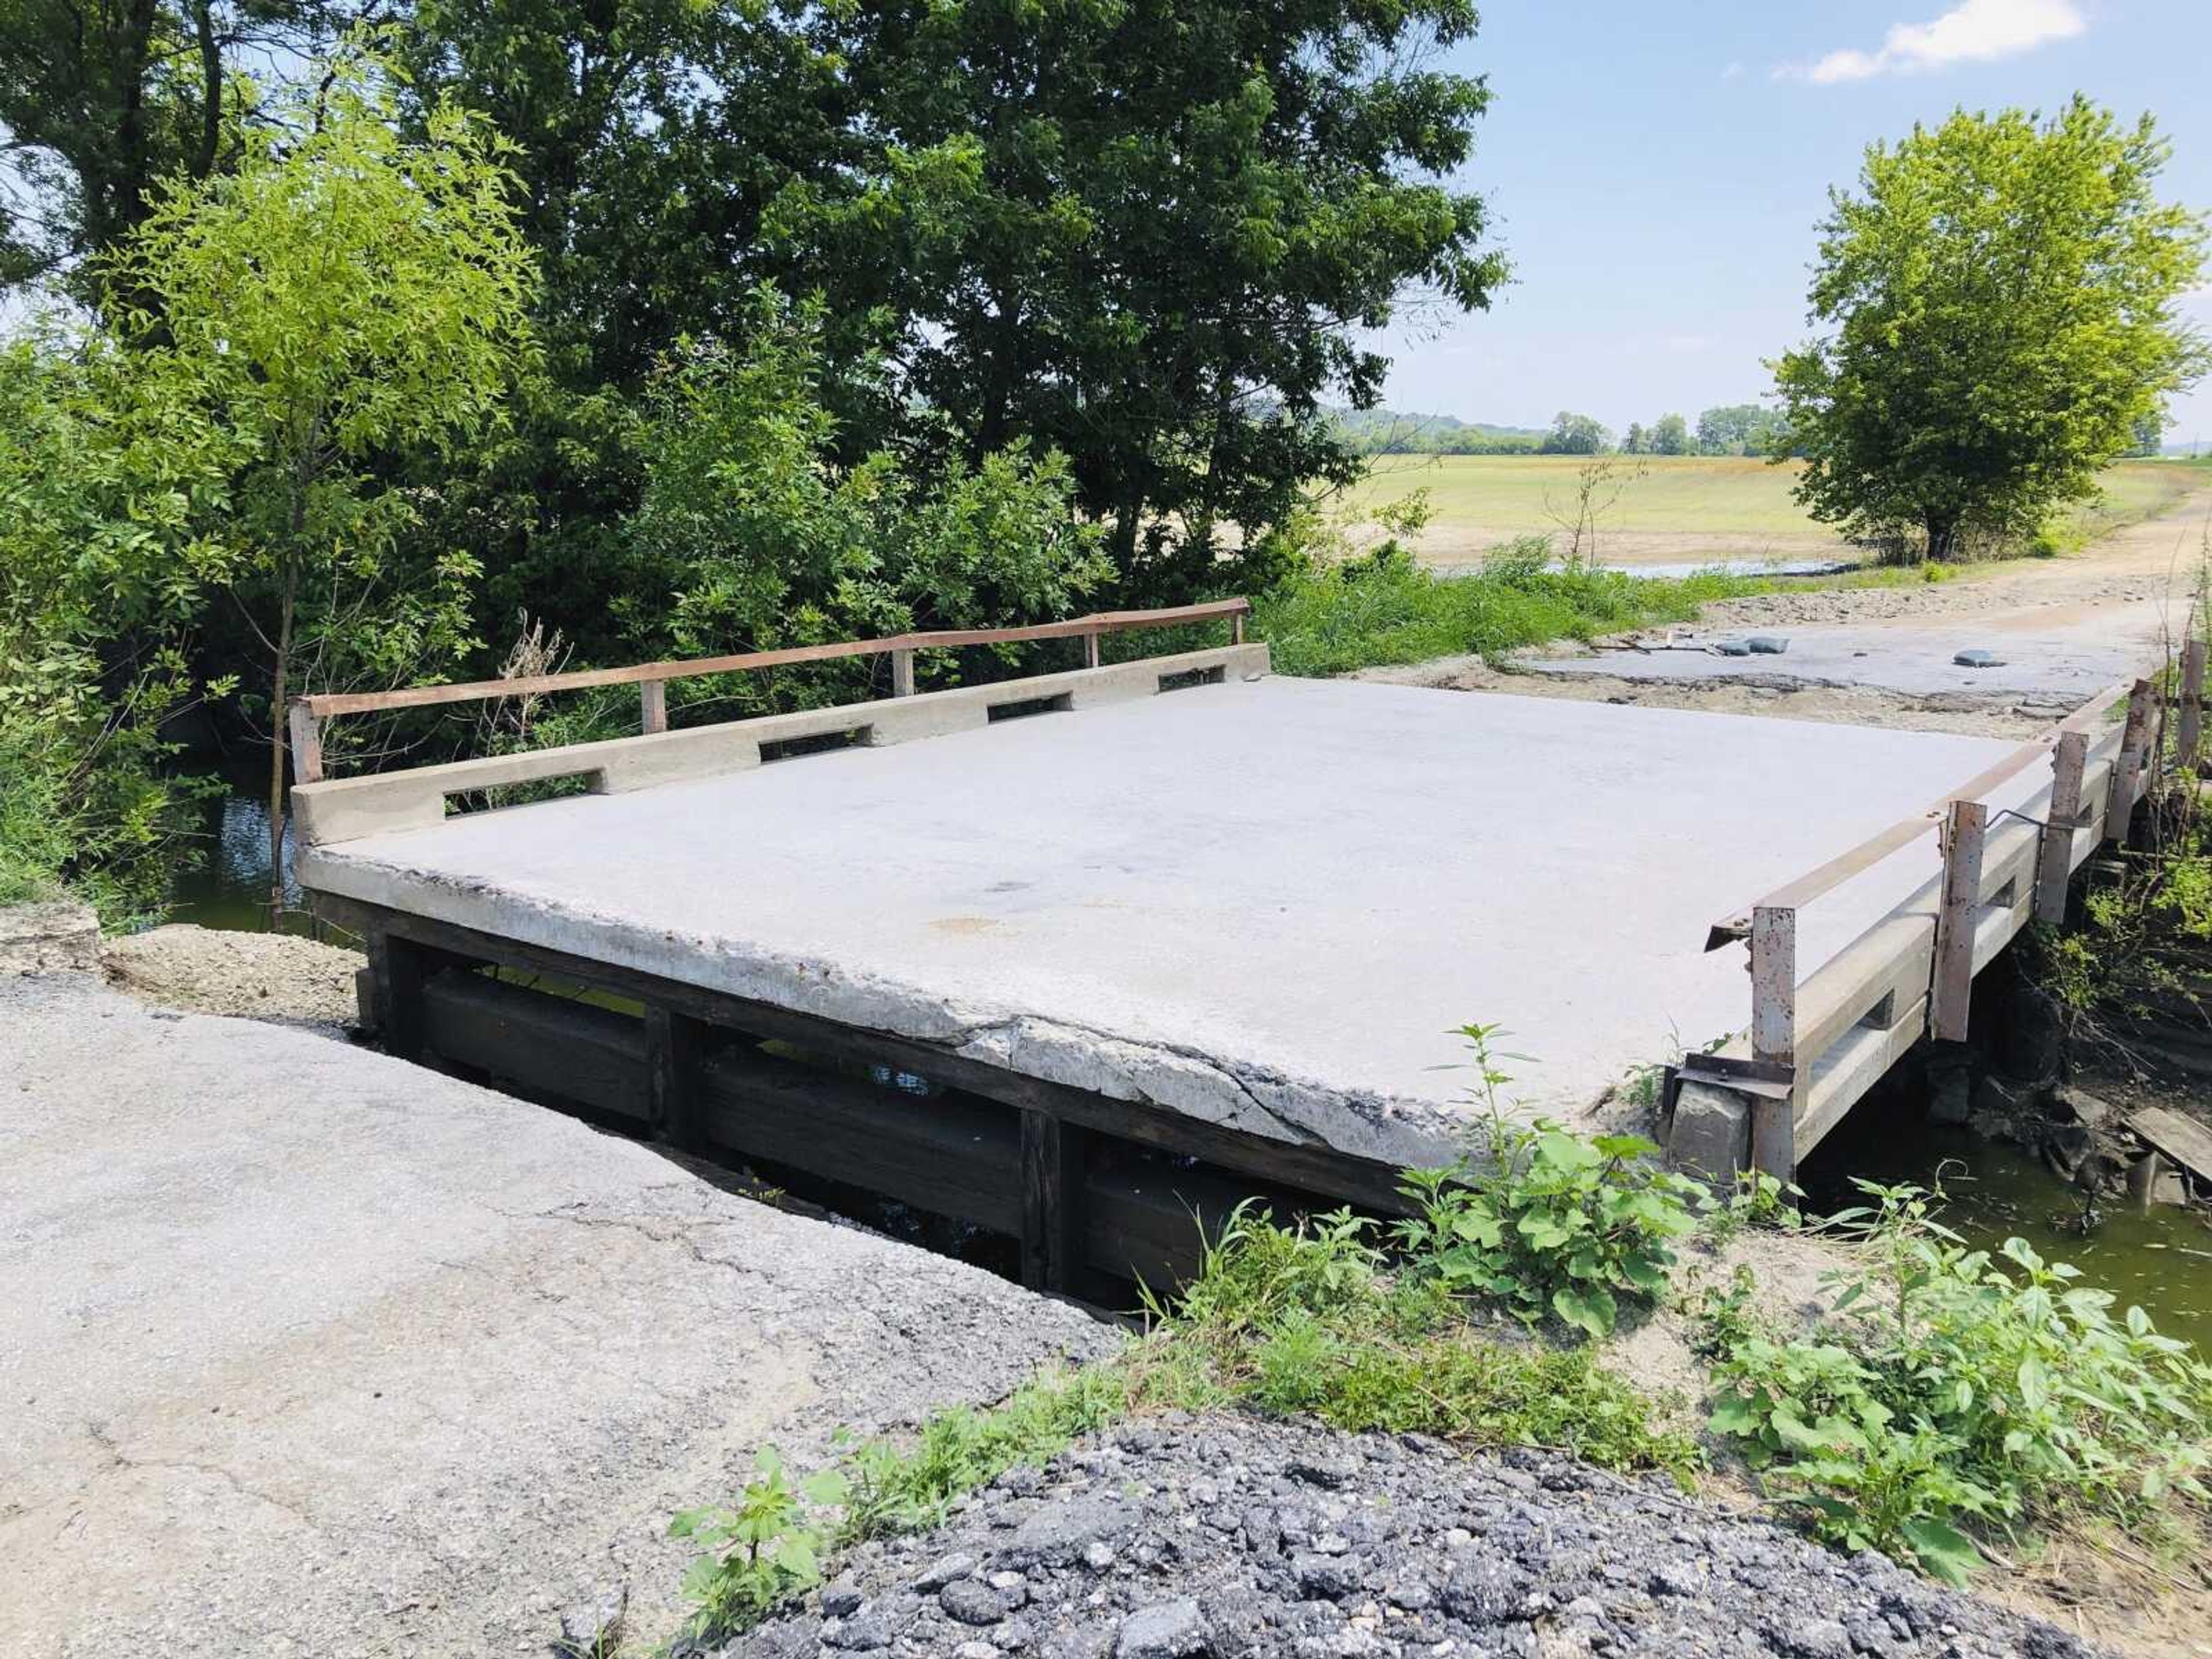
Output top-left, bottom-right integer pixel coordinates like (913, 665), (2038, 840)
(1351, 456), (2207, 564)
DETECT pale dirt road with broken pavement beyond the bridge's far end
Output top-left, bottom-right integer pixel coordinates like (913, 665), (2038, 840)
(1367, 487), (2212, 737)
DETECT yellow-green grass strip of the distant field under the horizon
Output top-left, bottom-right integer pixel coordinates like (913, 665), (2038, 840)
(1349, 456), (2205, 553)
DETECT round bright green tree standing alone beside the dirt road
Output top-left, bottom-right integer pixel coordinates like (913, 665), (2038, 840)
(1772, 97), (2205, 560)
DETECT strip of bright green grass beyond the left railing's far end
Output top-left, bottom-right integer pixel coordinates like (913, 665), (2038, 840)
(1252, 548), (1767, 675)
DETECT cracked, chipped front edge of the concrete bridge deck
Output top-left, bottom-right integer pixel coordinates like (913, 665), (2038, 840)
(301, 847), (1482, 1166)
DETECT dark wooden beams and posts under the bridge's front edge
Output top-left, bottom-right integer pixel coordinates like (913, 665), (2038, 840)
(312, 892), (1409, 1301)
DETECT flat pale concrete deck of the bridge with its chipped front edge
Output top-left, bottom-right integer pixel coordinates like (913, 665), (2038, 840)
(305, 679), (2031, 1157)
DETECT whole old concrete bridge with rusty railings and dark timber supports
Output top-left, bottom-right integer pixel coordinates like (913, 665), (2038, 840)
(290, 600), (2203, 1294)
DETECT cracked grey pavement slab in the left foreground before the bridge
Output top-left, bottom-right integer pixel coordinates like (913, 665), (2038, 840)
(0, 978), (1119, 1659)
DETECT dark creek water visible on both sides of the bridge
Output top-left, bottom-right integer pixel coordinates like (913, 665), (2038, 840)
(173, 790), (2212, 1354)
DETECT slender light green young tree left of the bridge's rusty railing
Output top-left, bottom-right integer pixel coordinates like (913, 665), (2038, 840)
(115, 48), (533, 925)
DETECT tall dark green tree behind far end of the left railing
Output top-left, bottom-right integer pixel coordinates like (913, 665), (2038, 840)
(767, 0), (1504, 590)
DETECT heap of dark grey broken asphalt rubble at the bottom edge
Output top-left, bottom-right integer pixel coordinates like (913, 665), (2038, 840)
(714, 1418), (2093, 1659)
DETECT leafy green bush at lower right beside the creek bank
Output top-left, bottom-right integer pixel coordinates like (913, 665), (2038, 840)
(1712, 1181), (2212, 1582)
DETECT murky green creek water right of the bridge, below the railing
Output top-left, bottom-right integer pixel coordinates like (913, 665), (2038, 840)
(1801, 1099), (2212, 1354)
